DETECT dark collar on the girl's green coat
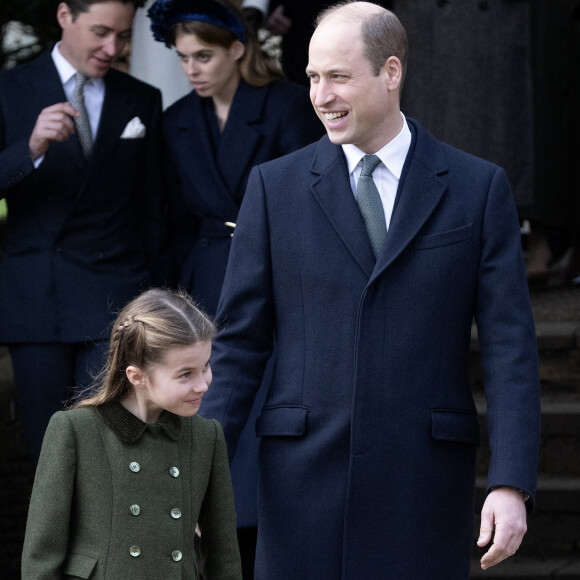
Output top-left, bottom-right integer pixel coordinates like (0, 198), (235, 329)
(97, 401), (182, 443)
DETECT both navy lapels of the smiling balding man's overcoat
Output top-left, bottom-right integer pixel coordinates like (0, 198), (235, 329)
(311, 119), (447, 282)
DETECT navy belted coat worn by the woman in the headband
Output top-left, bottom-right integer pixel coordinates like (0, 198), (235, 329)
(164, 80), (324, 527)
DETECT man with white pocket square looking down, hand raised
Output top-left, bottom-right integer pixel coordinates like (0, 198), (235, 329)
(0, 0), (163, 458)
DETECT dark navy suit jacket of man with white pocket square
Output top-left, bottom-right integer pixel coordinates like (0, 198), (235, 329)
(0, 53), (163, 343)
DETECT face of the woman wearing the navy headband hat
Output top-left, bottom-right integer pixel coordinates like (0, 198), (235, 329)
(175, 34), (245, 101)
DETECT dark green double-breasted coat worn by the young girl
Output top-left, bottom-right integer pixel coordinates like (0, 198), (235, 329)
(22, 403), (241, 580)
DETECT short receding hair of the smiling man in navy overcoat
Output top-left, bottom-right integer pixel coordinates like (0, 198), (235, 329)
(316, 0), (409, 81)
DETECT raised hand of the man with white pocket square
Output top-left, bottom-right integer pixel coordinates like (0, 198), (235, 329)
(28, 103), (80, 161)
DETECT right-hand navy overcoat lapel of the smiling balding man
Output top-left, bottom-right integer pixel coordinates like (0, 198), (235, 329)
(371, 121), (447, 281)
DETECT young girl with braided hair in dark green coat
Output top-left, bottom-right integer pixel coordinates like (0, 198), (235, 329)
(22, 289), (241, 580)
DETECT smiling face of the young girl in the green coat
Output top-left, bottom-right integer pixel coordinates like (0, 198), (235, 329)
(129, 341), (212, 423)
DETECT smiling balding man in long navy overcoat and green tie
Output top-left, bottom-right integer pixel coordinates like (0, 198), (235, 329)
(203, 2), (540, 580)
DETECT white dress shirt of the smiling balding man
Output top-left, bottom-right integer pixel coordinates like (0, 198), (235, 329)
(342, 113), (411, 230)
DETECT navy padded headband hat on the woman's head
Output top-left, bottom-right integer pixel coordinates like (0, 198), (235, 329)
(147, 0), (246, 46)
